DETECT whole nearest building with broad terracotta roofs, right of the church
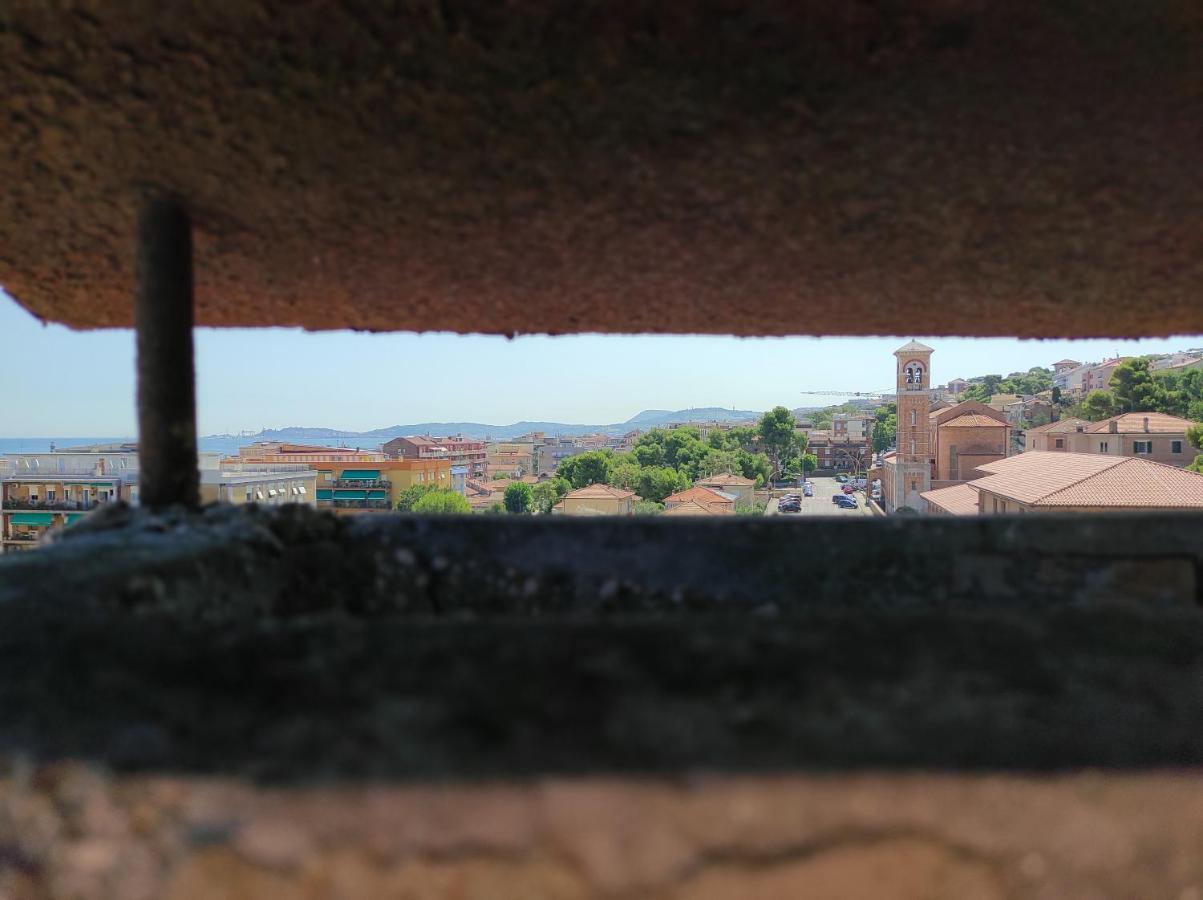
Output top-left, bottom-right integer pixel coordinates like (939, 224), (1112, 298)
(923, 451), (1203, 515)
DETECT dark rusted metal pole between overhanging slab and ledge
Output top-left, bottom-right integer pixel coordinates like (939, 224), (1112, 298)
(134, 199), (200, 508)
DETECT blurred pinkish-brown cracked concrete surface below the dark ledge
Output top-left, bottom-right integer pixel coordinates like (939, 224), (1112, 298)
(0, 764), (1203, 900)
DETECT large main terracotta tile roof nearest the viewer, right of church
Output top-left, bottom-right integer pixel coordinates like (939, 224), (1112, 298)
(973, 451), (1203, 509)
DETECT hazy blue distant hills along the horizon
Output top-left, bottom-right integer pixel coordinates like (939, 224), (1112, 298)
(202, 407), (760, 443)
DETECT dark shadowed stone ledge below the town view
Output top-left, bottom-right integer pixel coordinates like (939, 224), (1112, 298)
(0, 509), (1203, 780)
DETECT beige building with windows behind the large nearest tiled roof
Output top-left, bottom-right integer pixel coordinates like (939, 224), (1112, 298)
(1025, 413), (1196, 468)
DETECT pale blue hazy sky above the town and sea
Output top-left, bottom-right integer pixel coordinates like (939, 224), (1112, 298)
(0, 291), (1203, 437)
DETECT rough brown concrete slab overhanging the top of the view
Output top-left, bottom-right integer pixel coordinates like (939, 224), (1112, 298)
(0, 0), (1203, 337)
